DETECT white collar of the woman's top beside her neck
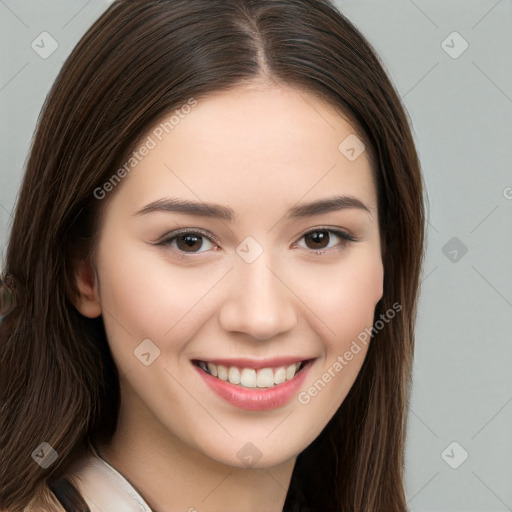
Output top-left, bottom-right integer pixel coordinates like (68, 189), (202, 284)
(67, 447), (153, 512)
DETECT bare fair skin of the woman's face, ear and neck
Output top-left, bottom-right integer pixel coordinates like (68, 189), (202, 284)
(77, 84), (384, 512)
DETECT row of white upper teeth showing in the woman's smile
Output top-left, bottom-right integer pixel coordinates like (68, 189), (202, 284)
(192, 360), (310, 389)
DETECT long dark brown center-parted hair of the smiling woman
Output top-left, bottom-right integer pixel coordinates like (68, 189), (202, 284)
(0, 0), (424, 512)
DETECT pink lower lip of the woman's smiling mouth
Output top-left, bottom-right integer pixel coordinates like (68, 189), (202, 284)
(194, 361), (313, 411)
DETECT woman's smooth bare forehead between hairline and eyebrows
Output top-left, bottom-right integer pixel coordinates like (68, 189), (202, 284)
(109, 86), (376, 221)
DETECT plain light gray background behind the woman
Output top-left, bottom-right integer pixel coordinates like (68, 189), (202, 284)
(0, 0), (512, 512)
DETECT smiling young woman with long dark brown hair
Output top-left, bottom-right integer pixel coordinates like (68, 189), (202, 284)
(0, 0), (424, 512)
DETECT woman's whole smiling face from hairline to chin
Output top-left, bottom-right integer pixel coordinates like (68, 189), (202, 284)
(78, 82), (383, 468)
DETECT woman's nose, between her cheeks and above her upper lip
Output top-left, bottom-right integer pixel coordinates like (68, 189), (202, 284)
(219, 253), (298, 341)
